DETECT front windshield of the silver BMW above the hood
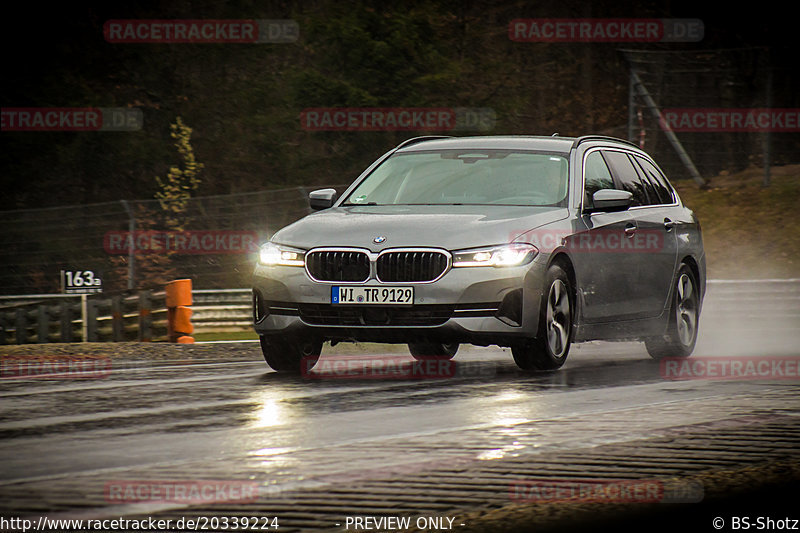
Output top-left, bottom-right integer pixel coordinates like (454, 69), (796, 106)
(342, 150), (567, 206)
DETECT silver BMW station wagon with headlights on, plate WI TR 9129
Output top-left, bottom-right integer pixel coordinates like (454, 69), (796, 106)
(253, 136), (706, 373)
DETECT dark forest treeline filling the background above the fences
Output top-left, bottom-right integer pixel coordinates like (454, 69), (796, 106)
(0, 0), (800, 210)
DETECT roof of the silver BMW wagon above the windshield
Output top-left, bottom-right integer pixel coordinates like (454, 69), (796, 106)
(397, 135), (635, 154)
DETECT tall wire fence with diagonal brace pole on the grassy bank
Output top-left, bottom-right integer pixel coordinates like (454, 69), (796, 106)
(622, 48), (800, 184)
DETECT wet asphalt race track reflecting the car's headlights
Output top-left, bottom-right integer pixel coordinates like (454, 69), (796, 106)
(0, 280), (800, 531)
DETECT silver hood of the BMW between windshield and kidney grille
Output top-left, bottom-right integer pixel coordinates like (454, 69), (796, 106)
(271, 205), (568, 252)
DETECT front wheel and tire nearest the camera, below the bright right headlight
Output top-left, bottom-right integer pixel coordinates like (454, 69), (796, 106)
(511, 265), (575, 370)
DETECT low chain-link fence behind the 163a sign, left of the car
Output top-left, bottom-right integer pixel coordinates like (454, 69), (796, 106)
(0, 186), (345, 294)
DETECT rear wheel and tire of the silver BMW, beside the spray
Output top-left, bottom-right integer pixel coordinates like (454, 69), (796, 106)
(644, 263), (700, 360)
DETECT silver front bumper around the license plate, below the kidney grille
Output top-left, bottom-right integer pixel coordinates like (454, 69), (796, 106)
(253, 257), (545, 346)
